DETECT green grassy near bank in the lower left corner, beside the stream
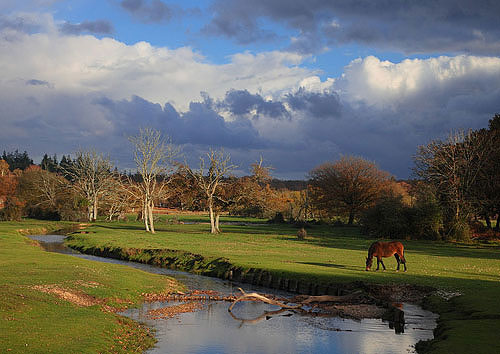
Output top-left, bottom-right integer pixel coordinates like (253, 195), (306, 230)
(0, 220), (184, 353)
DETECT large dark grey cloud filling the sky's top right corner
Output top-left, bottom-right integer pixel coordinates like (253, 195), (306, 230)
(206, 0), (500, 55)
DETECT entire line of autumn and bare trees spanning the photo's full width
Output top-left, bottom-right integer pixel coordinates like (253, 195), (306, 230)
(0, 114), (500, 240)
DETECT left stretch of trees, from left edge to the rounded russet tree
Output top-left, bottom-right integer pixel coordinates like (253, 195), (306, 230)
(0, 129), (310, 233)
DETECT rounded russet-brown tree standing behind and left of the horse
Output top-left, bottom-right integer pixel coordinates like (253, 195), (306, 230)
(309, 156), (389, 225)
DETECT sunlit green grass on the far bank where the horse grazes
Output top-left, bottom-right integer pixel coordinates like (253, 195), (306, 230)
(66, 215), (500, 353)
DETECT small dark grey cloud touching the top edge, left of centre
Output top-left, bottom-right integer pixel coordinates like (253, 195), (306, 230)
(120, 0), (174, 23)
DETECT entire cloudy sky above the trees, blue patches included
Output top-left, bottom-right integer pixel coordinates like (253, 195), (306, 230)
(0, 0), (500, 179)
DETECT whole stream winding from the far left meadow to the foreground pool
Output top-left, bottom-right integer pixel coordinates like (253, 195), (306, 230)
(30, 235), (438, 354)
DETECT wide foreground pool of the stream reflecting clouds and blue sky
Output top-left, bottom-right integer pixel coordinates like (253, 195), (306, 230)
(127, 302), (435, 354)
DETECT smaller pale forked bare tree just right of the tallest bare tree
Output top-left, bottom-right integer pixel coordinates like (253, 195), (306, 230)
(188, 149), (237, 234)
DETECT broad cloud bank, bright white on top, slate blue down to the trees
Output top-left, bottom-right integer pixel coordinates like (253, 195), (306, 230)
(0, 10), (500, 178)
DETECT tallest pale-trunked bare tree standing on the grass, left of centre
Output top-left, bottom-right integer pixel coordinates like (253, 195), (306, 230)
(129, 128), (180, 233)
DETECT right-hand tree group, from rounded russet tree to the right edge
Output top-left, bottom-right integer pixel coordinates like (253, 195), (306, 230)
(309, 114), (500, 241)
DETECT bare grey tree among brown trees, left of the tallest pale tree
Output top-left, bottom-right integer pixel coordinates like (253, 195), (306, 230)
(63, 150), (113, 221)
